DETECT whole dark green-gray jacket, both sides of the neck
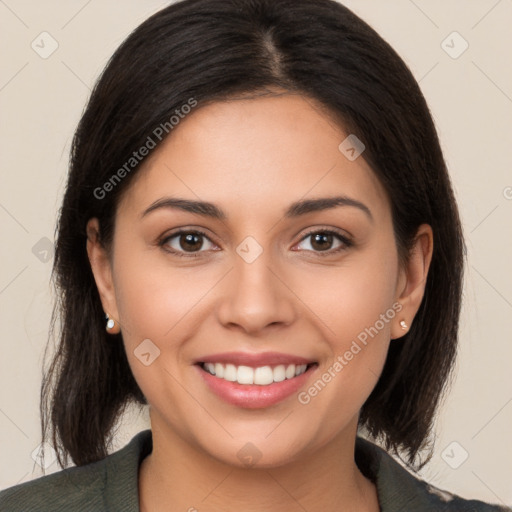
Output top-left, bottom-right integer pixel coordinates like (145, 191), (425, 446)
(0, 430), (512, 512)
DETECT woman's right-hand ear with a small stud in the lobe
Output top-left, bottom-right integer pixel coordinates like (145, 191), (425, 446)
(391, 224), (434, 339)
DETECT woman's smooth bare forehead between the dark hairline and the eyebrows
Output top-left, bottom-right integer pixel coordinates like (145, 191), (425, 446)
(119, 94), (389, 223)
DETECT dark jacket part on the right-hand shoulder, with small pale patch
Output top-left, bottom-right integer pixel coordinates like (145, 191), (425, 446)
(356, 437), (512, 512)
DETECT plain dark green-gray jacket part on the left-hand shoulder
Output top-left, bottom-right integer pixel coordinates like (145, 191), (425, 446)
(0, 430), (152, 512)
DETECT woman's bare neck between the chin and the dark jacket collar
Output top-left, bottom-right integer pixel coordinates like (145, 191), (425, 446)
(139, 414), (379, 512)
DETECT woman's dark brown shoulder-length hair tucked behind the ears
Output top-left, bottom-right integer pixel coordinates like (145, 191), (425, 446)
(41, 0), (464, 467)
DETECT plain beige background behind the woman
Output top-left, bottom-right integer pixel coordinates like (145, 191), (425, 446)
(0, 0), (512, 504)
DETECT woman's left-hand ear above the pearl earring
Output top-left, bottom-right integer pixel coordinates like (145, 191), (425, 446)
(86, 218), (119, 325)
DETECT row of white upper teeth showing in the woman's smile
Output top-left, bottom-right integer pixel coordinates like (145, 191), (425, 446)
(203, 363), (307, 386)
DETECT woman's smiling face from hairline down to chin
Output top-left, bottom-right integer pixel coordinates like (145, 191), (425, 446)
(89, 91), (428, 467)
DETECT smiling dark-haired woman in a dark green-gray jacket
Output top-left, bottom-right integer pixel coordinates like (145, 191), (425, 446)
(0, 0), (503, 512)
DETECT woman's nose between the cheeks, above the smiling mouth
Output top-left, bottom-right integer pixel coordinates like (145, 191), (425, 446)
(218, 251), (296, 334)
